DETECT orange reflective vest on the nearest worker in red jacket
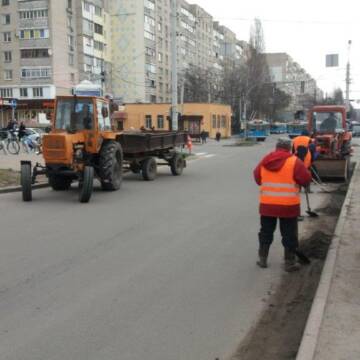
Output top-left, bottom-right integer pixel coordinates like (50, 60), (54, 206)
(260, 155), (300, 206)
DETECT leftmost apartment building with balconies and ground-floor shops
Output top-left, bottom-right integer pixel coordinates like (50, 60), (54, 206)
(0, 0), (111, 126)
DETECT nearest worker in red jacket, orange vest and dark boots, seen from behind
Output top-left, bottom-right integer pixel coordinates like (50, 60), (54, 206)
(254, 138), (311, 272)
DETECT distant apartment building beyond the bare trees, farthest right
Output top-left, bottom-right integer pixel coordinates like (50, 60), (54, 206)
(266, 53), (322, 120)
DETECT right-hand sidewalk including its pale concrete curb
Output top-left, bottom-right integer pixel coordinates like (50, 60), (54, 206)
(297, 156), (360, 360)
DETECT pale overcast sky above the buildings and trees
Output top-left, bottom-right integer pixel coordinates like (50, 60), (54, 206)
(190, 0), (360, 98)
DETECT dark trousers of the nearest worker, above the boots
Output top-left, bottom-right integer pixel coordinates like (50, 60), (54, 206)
(259, 216), (299, 251)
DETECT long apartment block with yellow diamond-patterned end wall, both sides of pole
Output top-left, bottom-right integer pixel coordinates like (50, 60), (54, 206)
(111, 0), (245, 103)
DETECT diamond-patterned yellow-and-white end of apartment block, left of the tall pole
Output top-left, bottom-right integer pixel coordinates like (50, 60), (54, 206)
(111, 0), (171, 102)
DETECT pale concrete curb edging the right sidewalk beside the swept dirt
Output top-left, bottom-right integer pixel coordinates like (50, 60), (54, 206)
(296, 163), (360, 360)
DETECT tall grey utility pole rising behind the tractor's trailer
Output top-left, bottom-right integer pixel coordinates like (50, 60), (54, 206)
(171, 0), (178, 131)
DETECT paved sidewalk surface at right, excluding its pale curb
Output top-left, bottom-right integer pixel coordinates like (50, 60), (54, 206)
(314, 162), (360, 360)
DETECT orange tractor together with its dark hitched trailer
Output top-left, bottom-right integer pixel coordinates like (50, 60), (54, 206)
(21, 96), (187, 203)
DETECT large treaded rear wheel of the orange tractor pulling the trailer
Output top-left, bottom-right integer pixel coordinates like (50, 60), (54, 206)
(99, 141), (123, 191)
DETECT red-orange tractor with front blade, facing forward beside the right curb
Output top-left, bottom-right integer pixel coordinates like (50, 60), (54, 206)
(308, 105), (352, 180)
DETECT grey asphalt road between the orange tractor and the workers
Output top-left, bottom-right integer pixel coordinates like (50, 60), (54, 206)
(0, 139), (300, 360)
